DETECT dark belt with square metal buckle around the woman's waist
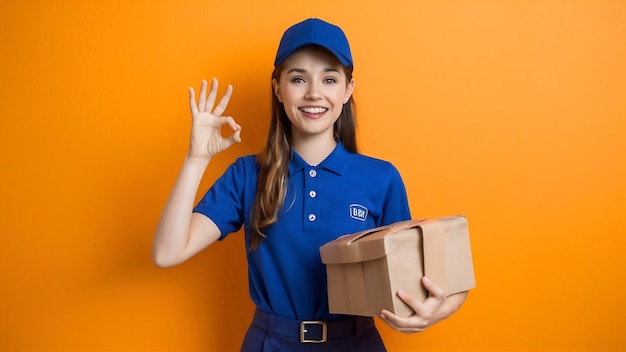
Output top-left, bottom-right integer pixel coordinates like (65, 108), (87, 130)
(252, 309), (374, 343)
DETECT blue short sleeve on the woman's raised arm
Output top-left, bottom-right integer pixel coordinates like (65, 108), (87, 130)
(193, 157), (256, 240)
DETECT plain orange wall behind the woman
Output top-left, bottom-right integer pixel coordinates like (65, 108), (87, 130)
(0, 0), (626, 351)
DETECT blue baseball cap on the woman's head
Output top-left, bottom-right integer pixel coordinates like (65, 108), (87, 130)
(274, 18), (354, 69)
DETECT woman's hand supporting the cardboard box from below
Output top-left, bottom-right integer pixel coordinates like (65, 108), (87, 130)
(380, 276), (467, 334)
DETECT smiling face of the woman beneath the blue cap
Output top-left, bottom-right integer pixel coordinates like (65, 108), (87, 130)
(272, 46), (354, 142)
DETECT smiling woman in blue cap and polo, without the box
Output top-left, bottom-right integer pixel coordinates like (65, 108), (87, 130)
(153, 19), (466, 351)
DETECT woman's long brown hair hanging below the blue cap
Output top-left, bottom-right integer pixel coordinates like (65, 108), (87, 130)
(250, 59), (358, 250)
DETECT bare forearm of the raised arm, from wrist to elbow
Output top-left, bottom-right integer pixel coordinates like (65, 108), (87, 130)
(152, 156), (210, 267)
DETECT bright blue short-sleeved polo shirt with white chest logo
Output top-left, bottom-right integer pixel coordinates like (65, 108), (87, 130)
(194, 143), (411, 320)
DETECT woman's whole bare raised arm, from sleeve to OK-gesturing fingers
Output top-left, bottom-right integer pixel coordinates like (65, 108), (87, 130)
(152, 78), (241, 267)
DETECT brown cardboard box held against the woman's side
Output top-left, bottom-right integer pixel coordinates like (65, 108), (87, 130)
(320, 216), (476, 317)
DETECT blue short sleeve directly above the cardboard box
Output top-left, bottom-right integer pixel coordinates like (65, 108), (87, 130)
(381, 165), (411, 226)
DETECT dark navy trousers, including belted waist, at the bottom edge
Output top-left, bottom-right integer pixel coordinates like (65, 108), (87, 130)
(241, 309), (387, 352)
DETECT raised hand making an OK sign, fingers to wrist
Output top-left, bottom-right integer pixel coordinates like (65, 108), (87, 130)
(189, 78), (241, 159)
